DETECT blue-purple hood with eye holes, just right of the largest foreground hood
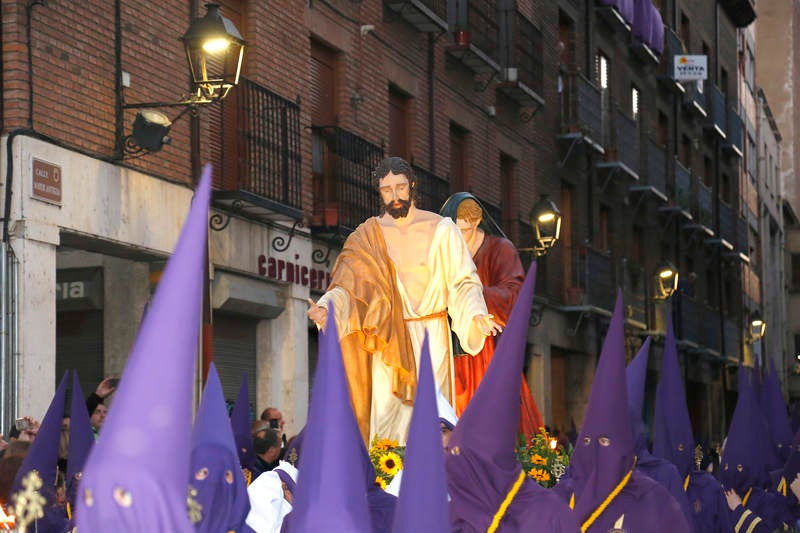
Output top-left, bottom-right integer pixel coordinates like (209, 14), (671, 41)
(188, 363), (250, 533)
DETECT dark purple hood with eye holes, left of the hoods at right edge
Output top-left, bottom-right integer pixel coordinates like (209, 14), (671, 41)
(719, 364), (769, 496)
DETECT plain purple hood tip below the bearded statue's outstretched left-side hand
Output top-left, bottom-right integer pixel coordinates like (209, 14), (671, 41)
(288, 306), (371, 533)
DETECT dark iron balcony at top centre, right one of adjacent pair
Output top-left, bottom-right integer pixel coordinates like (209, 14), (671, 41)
(497, 11), (544, 107)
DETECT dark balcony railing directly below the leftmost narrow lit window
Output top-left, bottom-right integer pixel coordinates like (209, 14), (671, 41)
(561, 72), (603, 142)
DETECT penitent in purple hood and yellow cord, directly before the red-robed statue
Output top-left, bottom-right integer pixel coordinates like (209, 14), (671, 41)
(445, 263), (579, 533)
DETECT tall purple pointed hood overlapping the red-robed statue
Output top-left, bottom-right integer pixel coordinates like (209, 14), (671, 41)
(445, 262), (536, 530)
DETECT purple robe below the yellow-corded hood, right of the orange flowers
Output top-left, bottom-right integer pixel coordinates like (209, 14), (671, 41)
(542, 470), (691, 533)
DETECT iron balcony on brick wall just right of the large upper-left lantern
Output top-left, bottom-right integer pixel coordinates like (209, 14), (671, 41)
(212, 79), (303, 227)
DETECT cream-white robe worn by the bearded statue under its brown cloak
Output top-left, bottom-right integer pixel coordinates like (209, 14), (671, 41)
(317, 217), (488, 445)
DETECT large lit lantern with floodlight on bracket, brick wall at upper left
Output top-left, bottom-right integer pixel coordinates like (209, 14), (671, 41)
(118, 2), (246, 156)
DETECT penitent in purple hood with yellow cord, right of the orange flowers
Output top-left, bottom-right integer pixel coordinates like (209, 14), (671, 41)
(554, 291), (691, 533)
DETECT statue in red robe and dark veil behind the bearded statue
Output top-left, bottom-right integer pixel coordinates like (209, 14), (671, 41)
(440, 192), (544, 438)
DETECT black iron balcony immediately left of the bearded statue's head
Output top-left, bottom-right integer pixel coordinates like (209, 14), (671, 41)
(311, 126), (383, 234)
